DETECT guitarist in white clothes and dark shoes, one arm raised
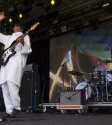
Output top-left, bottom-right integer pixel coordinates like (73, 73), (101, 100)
(0, 12), (32, 118)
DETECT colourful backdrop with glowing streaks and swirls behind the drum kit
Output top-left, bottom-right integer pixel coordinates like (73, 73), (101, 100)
(49, 22), (112, 103)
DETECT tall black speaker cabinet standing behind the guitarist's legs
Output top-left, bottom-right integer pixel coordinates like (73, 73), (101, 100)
(19, 71), (40, 109)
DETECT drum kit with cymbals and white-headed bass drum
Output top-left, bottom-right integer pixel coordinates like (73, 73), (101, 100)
(68, 60), (112, 102)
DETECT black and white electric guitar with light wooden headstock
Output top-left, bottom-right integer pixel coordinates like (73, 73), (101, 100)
(1, 22), (40, 66)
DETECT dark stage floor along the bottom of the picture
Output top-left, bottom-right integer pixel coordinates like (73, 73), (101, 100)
(0, 112), (112, 125)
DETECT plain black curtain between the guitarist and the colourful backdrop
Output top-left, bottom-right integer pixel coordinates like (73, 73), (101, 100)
(27, 39), (50, 103)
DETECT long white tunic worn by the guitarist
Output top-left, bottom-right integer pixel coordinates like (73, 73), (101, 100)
(0, 32), (32, 87)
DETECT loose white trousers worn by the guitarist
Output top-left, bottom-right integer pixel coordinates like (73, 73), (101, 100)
(1, 81), (21, 114)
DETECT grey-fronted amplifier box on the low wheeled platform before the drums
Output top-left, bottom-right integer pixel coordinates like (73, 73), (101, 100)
(60, 90), (86, 105)
